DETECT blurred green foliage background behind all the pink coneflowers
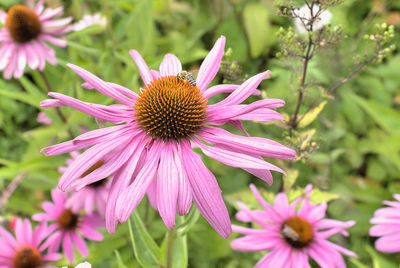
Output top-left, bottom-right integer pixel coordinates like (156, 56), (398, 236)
(0, 0), (400, 268)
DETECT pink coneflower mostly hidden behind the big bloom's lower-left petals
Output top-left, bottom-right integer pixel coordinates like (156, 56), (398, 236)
(58, 152), (111, 217)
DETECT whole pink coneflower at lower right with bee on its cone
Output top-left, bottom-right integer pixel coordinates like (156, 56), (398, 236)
(231, 185), (356, 268)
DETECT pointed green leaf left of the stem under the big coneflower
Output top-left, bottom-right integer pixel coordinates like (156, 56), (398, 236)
(128, 211), (161, 268)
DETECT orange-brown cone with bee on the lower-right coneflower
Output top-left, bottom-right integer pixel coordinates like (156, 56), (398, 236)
(281, 216), (313, 248)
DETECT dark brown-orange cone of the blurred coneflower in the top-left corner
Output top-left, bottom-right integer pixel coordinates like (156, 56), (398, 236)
(6, 5), (42, 43)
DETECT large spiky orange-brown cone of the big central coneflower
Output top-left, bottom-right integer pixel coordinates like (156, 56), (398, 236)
(135, 76), (207, 140)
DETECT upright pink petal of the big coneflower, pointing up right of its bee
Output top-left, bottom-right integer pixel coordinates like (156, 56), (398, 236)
(196, 36), (225, 91)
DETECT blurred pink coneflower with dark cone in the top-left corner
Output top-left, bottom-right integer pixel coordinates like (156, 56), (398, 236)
(0, 1), (72, 79)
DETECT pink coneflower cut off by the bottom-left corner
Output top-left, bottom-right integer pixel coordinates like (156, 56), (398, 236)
(0, 219), (61, 268)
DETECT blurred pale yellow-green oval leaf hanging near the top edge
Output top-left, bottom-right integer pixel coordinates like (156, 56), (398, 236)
(243, 3), (270, 58)
